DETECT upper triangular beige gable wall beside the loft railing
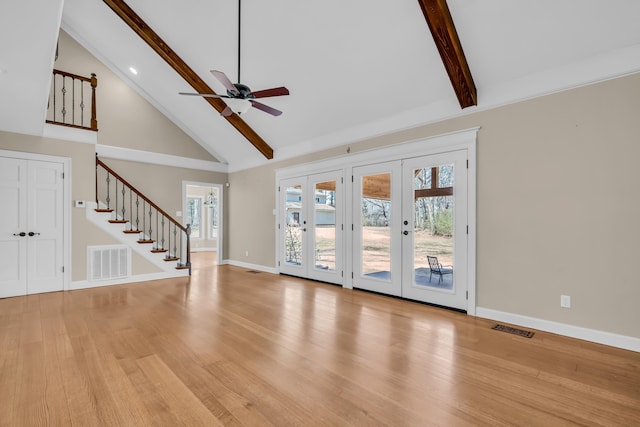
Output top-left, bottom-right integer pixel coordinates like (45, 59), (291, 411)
(54, 30), (216, 161)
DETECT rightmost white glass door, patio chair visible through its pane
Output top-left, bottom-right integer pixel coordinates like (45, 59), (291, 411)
(402, 150), (468, 310)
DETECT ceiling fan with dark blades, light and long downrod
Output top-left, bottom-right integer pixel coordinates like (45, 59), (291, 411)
(179, 0), (289, 116)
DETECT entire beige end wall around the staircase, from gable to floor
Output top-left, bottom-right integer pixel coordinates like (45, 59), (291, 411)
(0, 31), (227, 281)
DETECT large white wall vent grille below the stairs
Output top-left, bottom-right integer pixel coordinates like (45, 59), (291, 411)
(87, 245), (131, 281)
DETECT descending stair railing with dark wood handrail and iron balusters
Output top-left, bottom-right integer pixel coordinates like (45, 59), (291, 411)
(96, 154), (191, 274)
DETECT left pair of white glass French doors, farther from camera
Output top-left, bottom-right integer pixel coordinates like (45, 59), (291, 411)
(278, 171), (343, 284)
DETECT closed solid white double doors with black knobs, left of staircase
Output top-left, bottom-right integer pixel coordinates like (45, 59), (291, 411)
(0, 157), (64, 297)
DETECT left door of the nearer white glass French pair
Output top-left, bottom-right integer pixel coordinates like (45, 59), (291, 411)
(353, 161), (402, 296)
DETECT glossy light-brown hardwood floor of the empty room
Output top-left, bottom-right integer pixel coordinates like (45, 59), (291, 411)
(0, 253), (640, 427)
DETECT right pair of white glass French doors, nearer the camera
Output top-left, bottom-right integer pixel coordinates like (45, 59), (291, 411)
(352, 150), (468, 310)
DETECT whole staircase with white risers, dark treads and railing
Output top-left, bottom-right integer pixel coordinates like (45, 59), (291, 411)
(87, 155), (191, 276)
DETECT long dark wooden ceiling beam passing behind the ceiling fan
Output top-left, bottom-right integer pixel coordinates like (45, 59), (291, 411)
(103, 0), (273, 159)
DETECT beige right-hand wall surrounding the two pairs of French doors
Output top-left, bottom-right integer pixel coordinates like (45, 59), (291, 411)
(228, 74), (640, 337)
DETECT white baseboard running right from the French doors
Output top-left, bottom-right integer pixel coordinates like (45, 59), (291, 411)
(476, 307), (640, 352)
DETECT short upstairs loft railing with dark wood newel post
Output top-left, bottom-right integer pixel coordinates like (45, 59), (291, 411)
(46, 69), (98, 131)
